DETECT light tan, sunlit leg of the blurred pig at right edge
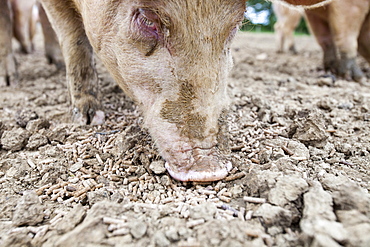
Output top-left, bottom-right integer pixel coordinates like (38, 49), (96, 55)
(329, 1), (369, 82)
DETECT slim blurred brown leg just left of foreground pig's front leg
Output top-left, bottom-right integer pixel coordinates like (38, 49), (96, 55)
(37, 4), (65, 69)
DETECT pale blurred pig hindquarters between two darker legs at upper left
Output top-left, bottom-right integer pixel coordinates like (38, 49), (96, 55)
(10, 0), (38, 54)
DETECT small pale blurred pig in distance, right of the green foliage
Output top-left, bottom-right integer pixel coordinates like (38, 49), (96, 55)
(272, 2), (303, 54)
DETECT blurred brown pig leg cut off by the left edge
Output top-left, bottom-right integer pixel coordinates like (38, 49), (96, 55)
(0, 0), (17, 87)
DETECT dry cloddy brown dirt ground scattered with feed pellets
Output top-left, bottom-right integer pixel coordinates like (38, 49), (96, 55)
(0, 27), (370, 247)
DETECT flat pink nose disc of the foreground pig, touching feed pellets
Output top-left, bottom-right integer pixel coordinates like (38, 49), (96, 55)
(165, 147), (232, 182)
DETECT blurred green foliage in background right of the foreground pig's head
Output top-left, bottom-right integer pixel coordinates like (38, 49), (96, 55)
(241, 0), (309, 34)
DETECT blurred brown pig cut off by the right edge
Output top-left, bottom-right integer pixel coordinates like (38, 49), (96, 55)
(305, 0), (370, 82)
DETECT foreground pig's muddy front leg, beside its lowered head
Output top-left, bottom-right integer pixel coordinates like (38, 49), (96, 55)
(41, 0), (104, 124)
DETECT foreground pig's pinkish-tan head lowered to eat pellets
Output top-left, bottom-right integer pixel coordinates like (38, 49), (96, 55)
(81, 0), (245, 181)
